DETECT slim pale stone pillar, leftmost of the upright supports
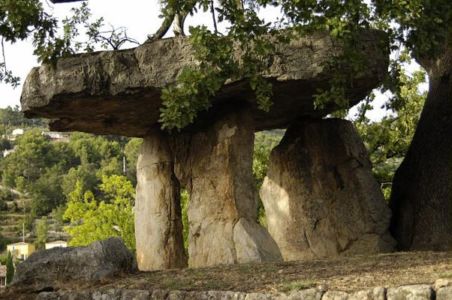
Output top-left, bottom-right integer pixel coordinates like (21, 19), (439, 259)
(135, 130), (187, 271)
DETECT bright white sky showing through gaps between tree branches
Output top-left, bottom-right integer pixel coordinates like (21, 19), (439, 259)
(0, 0), (420, 121)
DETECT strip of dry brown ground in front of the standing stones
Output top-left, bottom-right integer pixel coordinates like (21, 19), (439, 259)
(0, 252), (452, 297)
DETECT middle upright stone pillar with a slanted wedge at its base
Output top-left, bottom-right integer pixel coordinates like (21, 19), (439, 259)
(180, 112), (281, 267)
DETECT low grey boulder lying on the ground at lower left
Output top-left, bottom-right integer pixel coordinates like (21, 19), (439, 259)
(13, 238), (136, 290)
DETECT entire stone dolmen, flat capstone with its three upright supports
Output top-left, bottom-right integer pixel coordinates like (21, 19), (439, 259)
(21, 31), (394, 271)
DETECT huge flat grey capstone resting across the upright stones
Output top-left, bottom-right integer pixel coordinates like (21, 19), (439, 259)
(21, 31), (388, 136)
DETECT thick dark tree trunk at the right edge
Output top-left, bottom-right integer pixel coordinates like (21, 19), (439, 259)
(391, 47), (452, 250)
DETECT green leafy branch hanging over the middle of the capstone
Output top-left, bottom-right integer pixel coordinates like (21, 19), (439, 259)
(160, 1), (275, 129)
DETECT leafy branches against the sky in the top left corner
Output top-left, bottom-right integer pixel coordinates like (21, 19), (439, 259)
(0, 0), (137, 86)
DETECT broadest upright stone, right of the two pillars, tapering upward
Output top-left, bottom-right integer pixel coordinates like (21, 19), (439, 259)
(260, 119), (394, 260)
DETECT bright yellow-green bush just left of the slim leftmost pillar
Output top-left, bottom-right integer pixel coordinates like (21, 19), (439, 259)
(64, 175), (135, 250)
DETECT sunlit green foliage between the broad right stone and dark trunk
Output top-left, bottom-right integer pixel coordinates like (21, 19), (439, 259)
(355, 69), (426, 199)
